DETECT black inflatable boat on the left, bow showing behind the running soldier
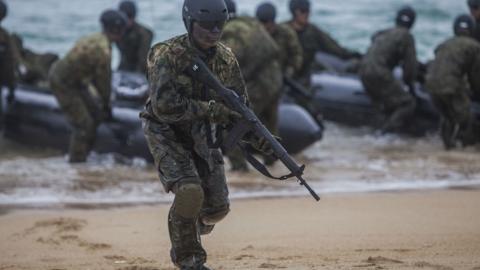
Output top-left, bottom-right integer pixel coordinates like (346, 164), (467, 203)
(1, 72), (323, 160)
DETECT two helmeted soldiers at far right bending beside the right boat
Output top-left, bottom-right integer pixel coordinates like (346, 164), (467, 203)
(359, 0), (480, 149)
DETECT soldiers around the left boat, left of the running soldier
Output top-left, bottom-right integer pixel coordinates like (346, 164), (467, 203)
(0, 0), (153, 163)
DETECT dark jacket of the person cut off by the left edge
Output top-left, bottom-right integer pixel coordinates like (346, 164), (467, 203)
(0, 27), (15, 90)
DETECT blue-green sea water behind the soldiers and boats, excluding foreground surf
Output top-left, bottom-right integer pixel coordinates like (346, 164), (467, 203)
(4, 0), (468, 60)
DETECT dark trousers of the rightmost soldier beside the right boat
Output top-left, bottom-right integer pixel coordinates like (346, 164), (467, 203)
(431, 86), (480, 149)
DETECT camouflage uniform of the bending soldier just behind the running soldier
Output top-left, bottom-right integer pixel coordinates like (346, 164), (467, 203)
(222, 17), (282, 169)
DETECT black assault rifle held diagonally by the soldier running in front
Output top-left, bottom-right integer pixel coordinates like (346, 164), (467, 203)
(186, 57), (320, 201)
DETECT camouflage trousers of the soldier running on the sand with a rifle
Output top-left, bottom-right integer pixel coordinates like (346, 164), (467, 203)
(143, 119), (230, 269)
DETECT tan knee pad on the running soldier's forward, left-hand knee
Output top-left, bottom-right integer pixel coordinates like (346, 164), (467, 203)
(174, 183), (204, 219)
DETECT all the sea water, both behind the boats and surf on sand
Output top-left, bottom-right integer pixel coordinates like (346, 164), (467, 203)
(0, 0), (480, 207)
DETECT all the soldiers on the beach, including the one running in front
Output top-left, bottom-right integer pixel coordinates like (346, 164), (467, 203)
(0, 0), (480, 270)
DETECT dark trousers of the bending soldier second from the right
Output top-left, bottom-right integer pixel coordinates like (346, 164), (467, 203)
(360, 65), (416, 131)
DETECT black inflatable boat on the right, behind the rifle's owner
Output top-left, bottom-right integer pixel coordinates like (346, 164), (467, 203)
(312, 53), (480, 135)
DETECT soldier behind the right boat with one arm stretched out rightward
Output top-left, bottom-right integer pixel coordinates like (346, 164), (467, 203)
(286, 0), (360, 88)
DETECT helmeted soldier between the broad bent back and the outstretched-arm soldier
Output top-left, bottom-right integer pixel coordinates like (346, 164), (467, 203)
(256, 2), (303, 77)
